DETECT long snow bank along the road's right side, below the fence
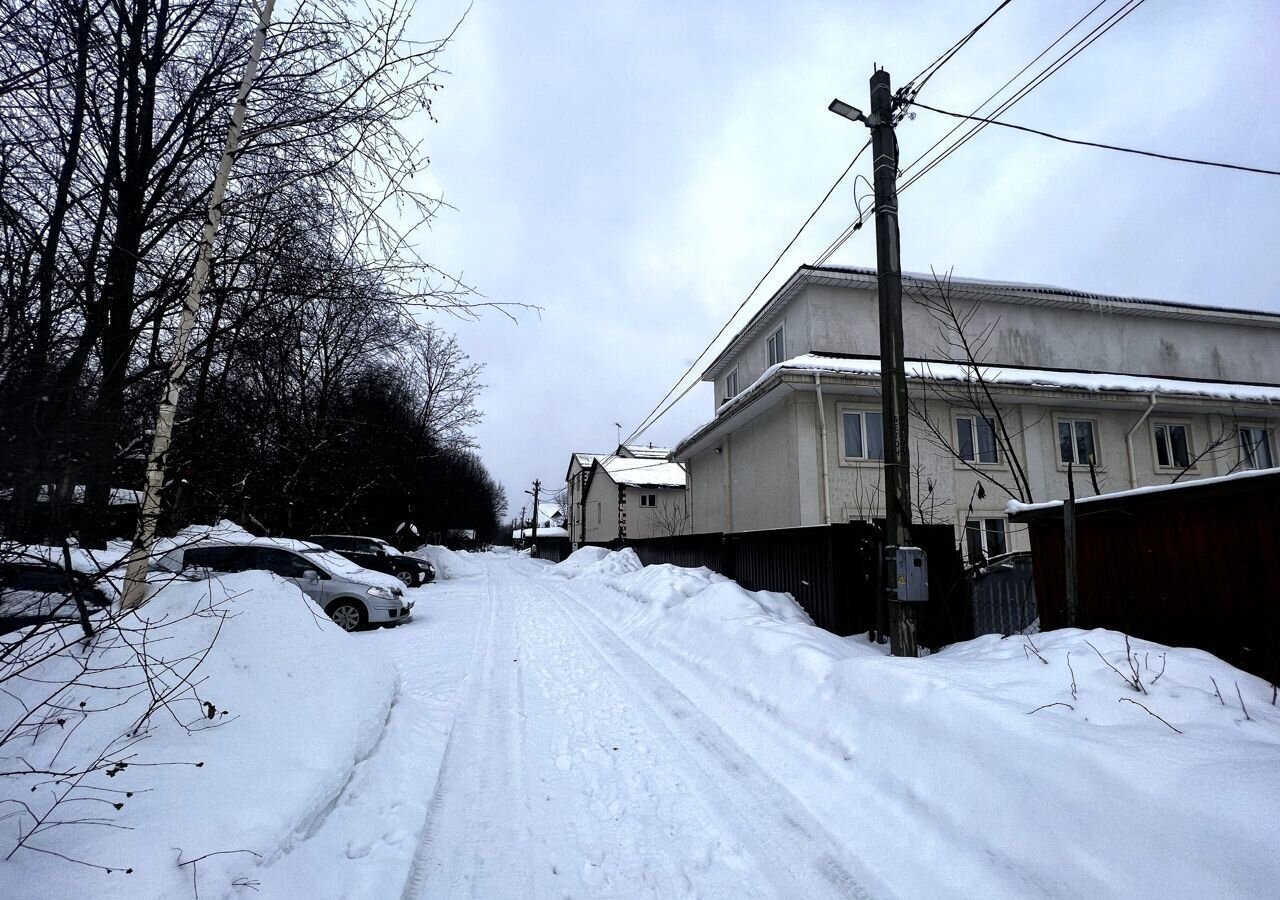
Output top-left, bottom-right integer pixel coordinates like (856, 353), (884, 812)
(558, 554), (1280, 900)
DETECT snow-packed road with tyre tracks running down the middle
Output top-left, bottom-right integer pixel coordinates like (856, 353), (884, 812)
(403, 559), (883, 900)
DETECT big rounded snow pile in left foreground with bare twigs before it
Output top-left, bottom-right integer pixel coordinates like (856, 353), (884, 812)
(0, 572), (398, 899)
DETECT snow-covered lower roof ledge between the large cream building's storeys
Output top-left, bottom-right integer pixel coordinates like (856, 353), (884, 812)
(716, 353), (1280, 415)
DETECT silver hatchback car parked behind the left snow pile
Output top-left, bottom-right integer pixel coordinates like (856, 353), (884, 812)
(157, 538), (413, 631)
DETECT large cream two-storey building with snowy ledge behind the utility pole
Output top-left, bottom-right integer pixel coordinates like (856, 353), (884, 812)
(673, 266), (1280, 558)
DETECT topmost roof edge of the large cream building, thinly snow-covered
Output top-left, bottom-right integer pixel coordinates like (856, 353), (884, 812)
(701, 265), (1280, 382)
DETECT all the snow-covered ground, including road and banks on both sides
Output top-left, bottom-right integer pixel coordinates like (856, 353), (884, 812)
(0, 549), (1280, 900)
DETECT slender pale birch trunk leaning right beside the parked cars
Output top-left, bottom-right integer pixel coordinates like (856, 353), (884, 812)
(120, 0), (275, 609)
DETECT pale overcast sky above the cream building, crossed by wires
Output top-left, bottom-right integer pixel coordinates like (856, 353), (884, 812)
(401, 0), (1280, 515)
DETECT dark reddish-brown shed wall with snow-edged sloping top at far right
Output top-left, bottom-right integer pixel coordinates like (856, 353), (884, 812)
(1011, 471), (1280, 682)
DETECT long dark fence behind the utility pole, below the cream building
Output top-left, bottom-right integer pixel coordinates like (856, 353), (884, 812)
(593, 522), (972, 648)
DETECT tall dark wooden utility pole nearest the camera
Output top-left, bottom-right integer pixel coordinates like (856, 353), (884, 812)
(867, 69), (918, 657)
